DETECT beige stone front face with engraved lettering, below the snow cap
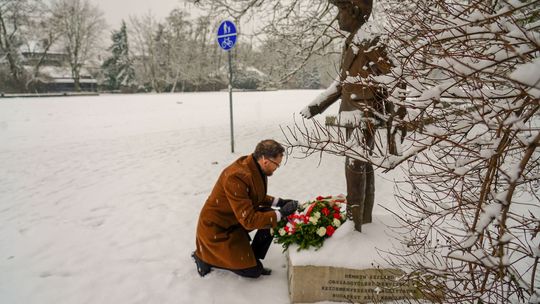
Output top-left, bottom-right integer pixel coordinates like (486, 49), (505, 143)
(288, 255), (418, 303)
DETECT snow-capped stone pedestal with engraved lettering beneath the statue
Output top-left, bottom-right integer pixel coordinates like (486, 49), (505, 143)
(287, 213), (442, 303)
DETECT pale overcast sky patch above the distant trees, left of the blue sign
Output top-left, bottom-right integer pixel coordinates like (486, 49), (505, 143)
(90, 0), (199, 29)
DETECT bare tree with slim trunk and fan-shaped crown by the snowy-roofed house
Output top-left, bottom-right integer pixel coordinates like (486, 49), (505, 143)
(52, 0), (105, 91)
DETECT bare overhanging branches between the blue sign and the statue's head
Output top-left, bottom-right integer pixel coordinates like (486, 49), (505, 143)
(190, 0), (344, 84)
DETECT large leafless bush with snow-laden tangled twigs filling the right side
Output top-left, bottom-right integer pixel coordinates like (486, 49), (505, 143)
(380, 1), (540, 303)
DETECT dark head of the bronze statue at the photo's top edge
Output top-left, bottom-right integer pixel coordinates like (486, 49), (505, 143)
(329, 0), (373, 32)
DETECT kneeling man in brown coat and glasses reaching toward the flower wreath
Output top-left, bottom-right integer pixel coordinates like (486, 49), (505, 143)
(192, 139), (298, 278)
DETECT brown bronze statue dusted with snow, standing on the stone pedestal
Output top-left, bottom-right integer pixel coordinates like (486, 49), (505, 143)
(301, 0), (396, 231)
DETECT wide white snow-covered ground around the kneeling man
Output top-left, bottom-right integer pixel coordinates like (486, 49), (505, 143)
(0, 91), (393, 304)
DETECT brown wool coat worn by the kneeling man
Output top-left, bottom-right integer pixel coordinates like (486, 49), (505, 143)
(196, 155), (277, 269)
